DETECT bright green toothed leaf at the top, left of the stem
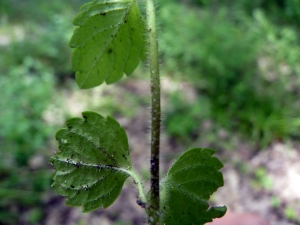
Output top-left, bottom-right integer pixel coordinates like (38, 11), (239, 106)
(70, 0), (146, 88)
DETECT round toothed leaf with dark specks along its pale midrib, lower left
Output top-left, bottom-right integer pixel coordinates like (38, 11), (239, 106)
(50, 112), (133, 212)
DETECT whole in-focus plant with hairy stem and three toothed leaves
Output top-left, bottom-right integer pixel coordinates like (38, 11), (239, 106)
(51, 0), (226, 225)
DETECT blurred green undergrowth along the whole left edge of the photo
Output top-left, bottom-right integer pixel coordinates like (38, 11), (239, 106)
(0, 0), (83, 225)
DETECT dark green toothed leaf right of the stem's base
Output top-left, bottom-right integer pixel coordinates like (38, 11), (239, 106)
(161, 148), (227, 225)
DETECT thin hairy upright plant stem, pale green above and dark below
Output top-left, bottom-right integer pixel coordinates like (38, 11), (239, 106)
(147, 0), (161, 225)
